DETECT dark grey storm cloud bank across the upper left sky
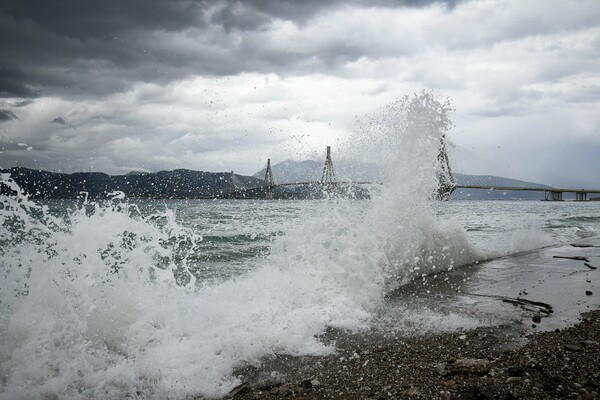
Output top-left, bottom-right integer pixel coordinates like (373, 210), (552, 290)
(0, 0), (458, 98)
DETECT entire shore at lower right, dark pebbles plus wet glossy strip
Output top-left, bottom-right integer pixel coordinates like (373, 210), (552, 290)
(229, 238), (600, 399)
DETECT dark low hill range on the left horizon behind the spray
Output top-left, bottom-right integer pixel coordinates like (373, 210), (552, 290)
(0, 168), (262, 199)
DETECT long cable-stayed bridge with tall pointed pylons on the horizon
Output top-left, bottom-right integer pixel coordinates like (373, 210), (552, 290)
(221, 144), (600, 201)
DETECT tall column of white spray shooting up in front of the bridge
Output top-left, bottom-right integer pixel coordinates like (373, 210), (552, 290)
(348, 91), (483, 289)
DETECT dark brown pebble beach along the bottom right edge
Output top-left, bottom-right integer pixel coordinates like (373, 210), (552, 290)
(227, 310), (600, 400)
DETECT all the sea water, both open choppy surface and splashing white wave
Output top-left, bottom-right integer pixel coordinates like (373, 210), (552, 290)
(0, 94), (600, 399)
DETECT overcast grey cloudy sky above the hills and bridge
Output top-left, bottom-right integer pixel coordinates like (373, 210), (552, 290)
(0, 0), (600, 188)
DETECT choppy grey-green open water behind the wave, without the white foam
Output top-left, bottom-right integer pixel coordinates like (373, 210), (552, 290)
(124, 200), (600, 281)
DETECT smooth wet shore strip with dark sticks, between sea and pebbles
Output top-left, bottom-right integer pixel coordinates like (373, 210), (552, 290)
(381, 236), (600, 334)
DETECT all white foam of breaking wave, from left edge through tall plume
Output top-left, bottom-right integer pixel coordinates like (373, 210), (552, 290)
(0, 93), (478, 399)
